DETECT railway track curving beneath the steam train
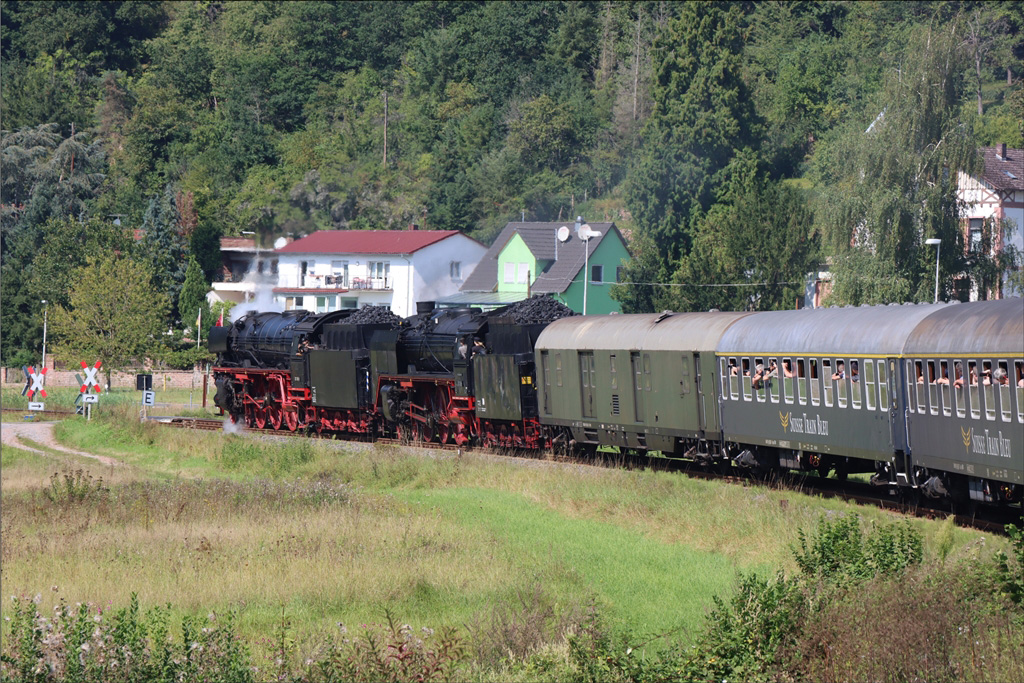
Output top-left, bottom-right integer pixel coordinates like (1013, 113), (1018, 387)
(151, 418), (1021, 533)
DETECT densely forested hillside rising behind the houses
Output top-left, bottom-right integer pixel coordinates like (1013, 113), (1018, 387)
(0, 0), (1024, 365)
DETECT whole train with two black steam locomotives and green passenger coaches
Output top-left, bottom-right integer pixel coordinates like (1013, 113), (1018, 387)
(210, 298), (1024, 507)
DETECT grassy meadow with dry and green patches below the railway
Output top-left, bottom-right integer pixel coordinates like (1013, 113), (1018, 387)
(0, 404), (1005, 679)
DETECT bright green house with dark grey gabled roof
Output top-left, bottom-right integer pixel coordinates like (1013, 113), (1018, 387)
(452, 219), (630, 314)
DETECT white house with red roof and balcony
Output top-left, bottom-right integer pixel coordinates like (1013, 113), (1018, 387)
(273, 229), (486, 317)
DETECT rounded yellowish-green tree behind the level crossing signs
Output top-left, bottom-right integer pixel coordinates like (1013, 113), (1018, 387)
(50, 254), (169, 381)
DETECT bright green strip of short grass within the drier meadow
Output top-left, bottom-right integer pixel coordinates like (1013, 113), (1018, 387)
(399, 488), (734, 634)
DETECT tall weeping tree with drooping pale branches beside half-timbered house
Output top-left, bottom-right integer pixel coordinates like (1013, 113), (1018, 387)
(816, 24), (977, 304)
